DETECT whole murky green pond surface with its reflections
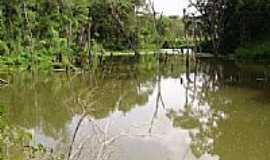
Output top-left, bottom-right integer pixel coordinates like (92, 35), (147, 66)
(0, 58), (270, 160)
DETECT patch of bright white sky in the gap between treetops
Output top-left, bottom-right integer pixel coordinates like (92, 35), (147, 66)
(153, 0), (188, 15)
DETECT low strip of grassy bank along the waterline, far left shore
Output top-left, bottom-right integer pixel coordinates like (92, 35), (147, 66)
(0, 50), (178, 72)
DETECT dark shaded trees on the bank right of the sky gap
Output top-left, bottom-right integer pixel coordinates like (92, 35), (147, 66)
(190, 0), (270, 59)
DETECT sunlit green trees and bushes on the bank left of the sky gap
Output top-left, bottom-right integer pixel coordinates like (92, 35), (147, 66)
(0, 0), (186, 69)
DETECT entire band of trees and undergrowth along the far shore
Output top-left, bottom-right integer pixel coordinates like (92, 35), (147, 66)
(0, 0), (270, 66)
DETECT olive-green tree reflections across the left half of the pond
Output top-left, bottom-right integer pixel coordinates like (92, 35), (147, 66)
(0, 56), (184, 139)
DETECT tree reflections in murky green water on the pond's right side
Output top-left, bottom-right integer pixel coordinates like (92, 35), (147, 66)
(168, 62), (270, 159)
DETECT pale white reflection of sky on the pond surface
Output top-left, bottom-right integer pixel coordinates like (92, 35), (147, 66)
(31, 74), (218, 160)
